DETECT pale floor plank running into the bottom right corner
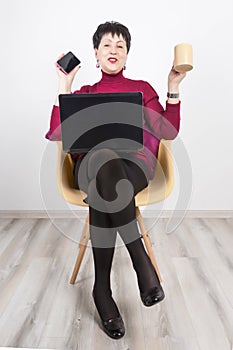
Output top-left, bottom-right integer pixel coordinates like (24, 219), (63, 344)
(173, 258), (231, 350)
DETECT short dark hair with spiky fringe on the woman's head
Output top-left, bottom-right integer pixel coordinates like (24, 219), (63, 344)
(92, 21), (131, 53)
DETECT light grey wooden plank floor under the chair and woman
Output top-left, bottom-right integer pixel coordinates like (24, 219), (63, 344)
(0, 218), (233, 350)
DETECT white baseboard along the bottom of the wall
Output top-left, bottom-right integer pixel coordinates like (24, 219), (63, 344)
(0, 208), (233, 219)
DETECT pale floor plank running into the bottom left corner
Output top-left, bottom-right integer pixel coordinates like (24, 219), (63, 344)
(0, 258), (51, 347)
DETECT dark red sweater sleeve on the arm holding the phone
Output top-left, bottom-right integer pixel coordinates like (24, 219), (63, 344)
(45, 85), (89, 141)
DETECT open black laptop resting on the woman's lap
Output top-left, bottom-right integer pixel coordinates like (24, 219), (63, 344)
(59, 92), (143, 153)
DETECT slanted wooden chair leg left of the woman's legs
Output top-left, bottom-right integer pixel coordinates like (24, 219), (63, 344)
(70, 214), (90, 284)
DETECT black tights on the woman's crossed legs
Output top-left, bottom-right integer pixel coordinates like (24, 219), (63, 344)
(74, 149), (159, 320)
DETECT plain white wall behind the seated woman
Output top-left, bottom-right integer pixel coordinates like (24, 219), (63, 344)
(0, 0), (233, 210)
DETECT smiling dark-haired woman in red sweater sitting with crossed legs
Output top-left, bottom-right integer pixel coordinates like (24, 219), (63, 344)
(46, 22), (185, 339)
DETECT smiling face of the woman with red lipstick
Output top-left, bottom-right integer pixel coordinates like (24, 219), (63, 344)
(95, 33), (127, 74)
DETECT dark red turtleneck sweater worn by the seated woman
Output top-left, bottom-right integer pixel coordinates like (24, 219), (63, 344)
(45, 71), (180, 178)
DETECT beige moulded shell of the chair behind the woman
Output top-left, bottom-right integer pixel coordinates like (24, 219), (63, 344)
(57, 140), (174, 207)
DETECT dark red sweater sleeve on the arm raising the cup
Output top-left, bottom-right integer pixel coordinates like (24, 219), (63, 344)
(144, 82), (180, 140)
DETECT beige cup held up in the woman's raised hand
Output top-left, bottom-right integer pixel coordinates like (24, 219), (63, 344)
(174, 43), (193, 73)
